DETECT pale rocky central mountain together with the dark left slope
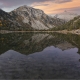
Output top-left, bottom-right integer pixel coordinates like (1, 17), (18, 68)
(0, 5), (64, 30)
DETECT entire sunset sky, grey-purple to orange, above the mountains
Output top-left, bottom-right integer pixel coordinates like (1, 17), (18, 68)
(0, 0), (80, 15)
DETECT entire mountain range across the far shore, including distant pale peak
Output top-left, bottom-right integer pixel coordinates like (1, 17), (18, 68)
(0, 5), (80, 31)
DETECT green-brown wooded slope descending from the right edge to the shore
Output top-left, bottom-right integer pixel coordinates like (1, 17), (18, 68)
(52, 16), (80, 30)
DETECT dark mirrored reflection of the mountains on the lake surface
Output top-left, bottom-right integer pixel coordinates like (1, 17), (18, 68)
(0, 33), (80, 54)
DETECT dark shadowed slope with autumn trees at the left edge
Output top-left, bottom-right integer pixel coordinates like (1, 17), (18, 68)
(0, 9), (20, 30)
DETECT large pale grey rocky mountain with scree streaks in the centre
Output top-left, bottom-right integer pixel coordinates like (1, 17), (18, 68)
(10, 5), (63, 30)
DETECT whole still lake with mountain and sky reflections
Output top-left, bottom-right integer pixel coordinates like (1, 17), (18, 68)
(0, 33), (80, 79)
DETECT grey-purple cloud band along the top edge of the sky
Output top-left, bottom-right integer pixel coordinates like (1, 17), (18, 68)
(0, 0), (72, 8)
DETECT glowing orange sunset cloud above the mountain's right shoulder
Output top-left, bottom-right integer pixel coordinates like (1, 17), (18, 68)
(31, 0), (80, 14)
